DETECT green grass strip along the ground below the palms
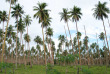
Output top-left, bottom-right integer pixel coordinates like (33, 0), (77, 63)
(0, 65), (110, 74)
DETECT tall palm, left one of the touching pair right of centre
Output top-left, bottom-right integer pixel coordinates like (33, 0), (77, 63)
(60, 8), (74, 54)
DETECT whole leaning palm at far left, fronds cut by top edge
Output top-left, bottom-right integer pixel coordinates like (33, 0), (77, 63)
(1, 0), (17, 62)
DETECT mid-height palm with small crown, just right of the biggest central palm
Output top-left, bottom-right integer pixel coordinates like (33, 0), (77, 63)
(46, 27), (54, 65)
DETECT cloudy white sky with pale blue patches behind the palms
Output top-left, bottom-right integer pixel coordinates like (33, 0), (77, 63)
(0, 0), (110, 48)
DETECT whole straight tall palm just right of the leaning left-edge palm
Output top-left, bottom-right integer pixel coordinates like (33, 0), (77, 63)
(11, 4), (24, 68)
